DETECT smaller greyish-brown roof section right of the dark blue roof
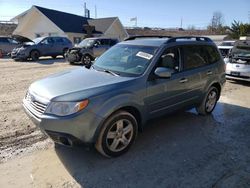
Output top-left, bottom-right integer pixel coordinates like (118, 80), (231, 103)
(88, 17), (117, 33)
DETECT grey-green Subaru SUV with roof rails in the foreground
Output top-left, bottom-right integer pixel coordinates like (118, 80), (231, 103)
(23, 37), (225, 157)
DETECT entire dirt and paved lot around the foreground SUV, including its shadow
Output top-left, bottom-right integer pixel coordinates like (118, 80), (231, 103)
(0, 59), (250, 188)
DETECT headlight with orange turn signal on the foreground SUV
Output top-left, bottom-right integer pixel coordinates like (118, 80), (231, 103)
(46, 100), (89, 116)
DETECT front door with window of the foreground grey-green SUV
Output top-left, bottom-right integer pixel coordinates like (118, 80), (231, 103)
(145, 47), (194, 117)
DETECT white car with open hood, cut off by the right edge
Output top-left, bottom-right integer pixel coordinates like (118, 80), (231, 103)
(226, 40), (250, 81)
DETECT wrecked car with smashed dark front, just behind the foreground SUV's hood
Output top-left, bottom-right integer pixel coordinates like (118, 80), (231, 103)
(66, 38), (118, 65)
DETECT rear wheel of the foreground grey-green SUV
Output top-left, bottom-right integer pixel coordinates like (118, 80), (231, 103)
(196, 86), (219, 115)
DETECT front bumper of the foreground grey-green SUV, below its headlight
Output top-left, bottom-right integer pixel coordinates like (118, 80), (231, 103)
(23, 102), (103, 145)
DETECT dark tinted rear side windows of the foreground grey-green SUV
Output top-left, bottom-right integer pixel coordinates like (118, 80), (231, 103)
(183, 45), (220, 70)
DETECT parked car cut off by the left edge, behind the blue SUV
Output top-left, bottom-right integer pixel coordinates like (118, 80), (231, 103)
(0, 36), (19, 55)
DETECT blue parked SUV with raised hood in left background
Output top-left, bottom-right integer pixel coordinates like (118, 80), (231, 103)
(11, 36), (72, 61)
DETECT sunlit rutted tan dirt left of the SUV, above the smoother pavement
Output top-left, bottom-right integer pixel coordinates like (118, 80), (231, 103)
(0, 59), (72, 162)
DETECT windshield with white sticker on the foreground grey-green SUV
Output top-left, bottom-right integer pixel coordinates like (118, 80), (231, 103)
(93, 44), (157, 76)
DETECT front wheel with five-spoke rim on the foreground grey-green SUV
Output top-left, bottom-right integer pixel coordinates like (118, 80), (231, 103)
(95, 111), (138, 157)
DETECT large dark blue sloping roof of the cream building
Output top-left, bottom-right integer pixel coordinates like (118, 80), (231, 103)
(34, 6), (102, 33)
